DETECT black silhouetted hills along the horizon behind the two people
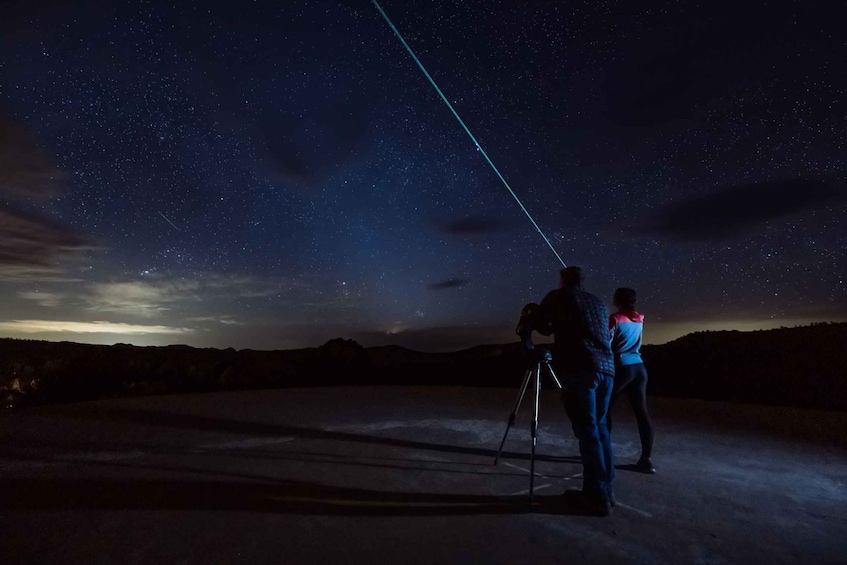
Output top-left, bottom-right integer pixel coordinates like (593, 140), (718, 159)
(0, 323), (847, 410)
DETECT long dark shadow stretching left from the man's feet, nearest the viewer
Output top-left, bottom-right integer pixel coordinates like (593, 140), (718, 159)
(0, 479), (604, 516)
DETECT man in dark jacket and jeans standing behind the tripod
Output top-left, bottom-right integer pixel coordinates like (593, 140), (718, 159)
(533, 267), (615, 516)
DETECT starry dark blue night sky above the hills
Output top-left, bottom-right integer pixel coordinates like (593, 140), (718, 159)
(0, 0), (847, 351)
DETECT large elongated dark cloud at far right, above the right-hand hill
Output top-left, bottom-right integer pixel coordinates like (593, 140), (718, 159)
(637, 178), (845, 240)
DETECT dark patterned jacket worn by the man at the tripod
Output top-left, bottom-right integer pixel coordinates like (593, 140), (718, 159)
(533, 287), (615, 376)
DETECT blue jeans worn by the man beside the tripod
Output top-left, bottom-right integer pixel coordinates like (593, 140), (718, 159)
(562, 371), (615, 499)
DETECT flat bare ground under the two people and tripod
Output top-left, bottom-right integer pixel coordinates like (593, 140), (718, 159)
(0, 386), (847, 565)
